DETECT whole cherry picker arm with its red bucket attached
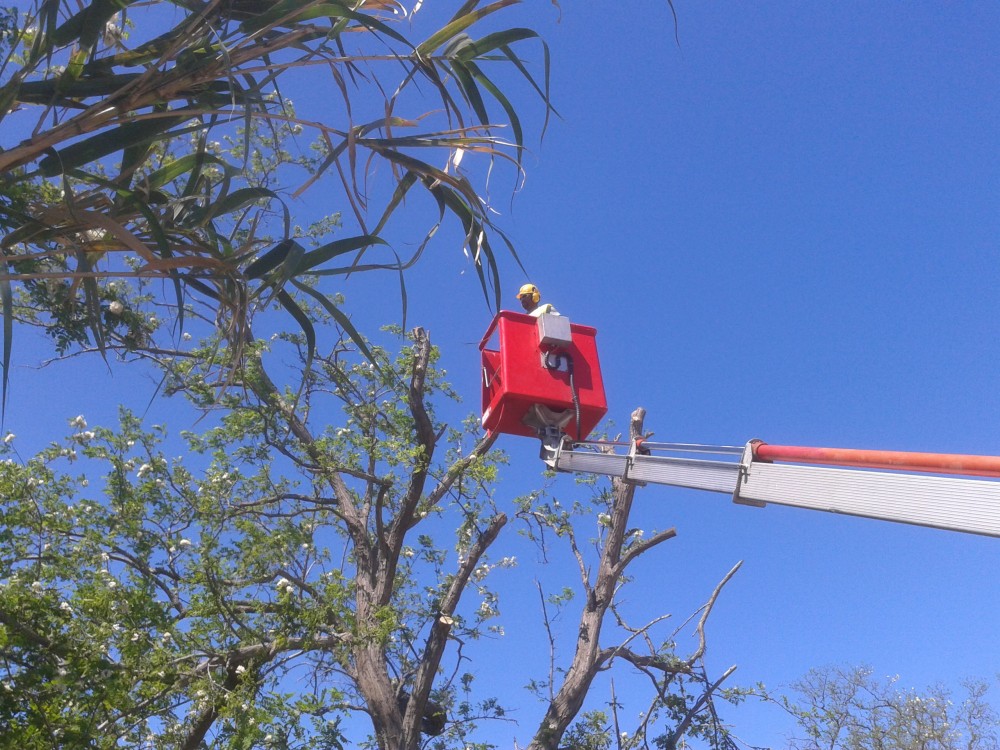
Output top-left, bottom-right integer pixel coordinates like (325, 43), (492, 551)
(480, 311), (1000, 537)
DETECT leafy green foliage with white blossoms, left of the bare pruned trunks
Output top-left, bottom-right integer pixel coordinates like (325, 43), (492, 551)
(0, 332), (512, 748)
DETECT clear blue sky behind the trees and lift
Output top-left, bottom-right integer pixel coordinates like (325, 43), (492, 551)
(8, 0), (1000, 747)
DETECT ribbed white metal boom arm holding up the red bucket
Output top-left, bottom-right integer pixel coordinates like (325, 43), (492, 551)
(543, 441), (1000, 537)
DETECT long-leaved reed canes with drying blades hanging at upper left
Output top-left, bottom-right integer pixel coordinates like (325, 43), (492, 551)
(0, 0), (551, 406)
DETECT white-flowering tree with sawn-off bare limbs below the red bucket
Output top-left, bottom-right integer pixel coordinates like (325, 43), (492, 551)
(0, 322), (735, 750)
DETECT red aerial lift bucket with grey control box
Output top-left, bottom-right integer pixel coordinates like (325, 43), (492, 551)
(479, 310), (608, 440)
